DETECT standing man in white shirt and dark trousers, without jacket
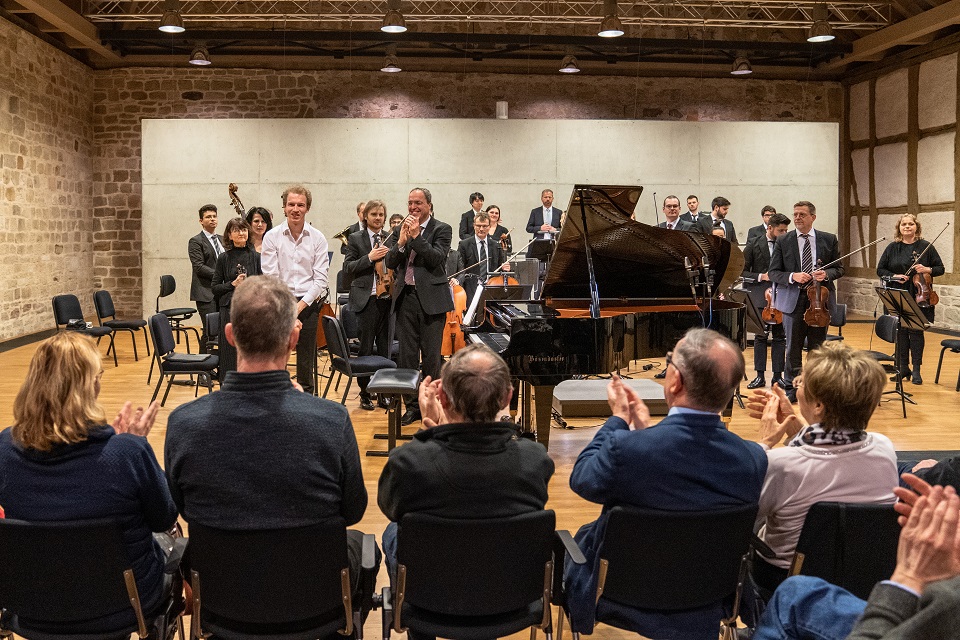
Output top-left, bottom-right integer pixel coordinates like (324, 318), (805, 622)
(260, 185), (330, 394)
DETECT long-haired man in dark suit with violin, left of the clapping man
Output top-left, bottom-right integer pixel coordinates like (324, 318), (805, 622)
(343, 200), (390, 411)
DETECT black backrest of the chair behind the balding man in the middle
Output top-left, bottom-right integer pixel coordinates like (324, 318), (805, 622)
(397, 511), (556, 616)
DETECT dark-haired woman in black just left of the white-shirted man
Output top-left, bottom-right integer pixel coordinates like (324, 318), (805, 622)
(213, 218), (263, 382)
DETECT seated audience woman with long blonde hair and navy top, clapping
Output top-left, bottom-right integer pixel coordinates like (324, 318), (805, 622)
(0, 331), (177, 634)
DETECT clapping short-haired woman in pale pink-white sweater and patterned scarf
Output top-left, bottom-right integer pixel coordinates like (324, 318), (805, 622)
(751, 342), (897, 597)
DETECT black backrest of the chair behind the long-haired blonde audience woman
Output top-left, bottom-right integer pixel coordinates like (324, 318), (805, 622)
(0, 519), (132, 630)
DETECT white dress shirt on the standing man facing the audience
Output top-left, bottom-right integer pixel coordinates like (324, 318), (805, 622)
(260, 222), (330, 306)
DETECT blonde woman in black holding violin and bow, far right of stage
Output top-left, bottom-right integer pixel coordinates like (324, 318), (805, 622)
(877, 213), (944, 384)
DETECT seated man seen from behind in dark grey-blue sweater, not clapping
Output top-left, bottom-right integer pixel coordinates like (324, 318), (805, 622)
(164, 276), (378, 585)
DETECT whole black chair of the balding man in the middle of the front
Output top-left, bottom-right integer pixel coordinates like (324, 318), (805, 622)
(383, 511), (579, 640)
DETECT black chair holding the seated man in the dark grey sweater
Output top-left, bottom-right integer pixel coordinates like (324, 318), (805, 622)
(190, 518), (376, 640)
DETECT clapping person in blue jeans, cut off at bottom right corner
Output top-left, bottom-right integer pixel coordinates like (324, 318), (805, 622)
(753, 474), (960, 640)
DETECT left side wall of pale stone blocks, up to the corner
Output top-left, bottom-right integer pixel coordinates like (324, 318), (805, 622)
(0, 19), (95, 342)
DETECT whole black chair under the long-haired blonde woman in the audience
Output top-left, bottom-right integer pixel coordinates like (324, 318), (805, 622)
(0, 519), (186, 640)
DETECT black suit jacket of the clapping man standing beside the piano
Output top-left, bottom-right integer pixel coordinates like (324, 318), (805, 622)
(384, 217), (453, 315)
